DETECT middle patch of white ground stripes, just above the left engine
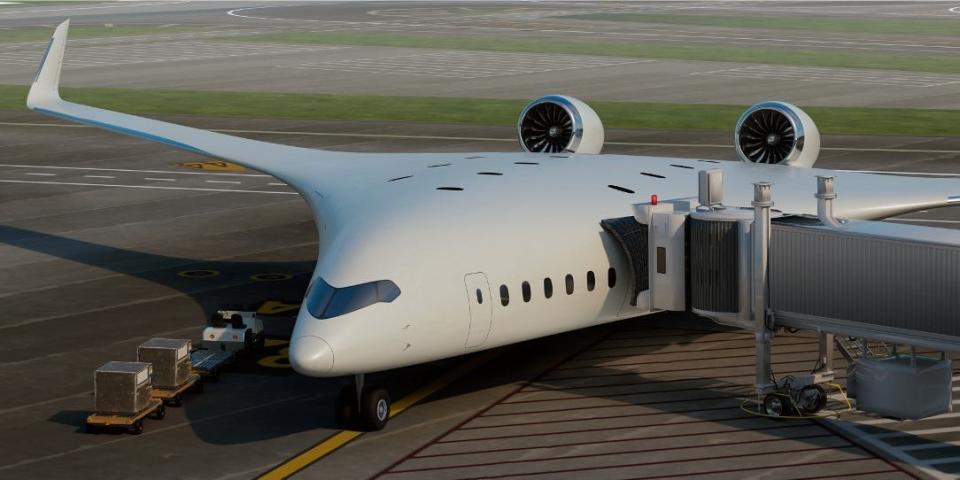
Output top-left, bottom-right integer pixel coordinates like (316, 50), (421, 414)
(278, 51), (654, 79)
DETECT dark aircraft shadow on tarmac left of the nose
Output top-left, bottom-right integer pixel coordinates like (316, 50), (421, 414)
(0, 225), (360, 444)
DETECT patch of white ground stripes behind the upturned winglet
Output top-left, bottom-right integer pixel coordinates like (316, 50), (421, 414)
(0, 41), (350, 68)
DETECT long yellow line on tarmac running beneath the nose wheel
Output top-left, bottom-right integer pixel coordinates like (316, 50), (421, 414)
(259, 351), (499, 480)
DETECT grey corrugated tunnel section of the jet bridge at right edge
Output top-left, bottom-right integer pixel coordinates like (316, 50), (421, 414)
(769, 217), (960, 350)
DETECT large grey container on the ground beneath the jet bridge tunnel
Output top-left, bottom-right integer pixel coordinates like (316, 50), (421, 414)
(847, 356), (953, 420)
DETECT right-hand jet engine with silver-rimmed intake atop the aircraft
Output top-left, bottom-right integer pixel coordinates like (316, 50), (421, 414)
(734, 102), (820, 167)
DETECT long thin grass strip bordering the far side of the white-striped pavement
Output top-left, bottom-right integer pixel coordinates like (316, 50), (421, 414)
(229, 32), (960, 73)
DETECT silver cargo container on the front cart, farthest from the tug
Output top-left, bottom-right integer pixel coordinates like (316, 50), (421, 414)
(93, 362), (152, 416)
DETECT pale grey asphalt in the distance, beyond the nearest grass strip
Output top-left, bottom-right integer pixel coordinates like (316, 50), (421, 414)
(0, 2), (960, 108)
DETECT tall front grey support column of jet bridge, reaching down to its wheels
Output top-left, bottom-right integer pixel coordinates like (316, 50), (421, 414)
(751, 182), (776, 395)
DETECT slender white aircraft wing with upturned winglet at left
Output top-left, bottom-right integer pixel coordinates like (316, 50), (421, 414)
(27, 20), (344, 192)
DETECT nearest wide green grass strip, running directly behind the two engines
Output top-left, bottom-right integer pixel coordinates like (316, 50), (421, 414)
(0, 85), (960, 136)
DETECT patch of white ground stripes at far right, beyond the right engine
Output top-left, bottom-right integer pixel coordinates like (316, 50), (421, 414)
(690, 65), (960, 88)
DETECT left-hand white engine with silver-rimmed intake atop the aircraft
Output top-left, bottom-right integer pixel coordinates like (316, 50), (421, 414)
(517, 95), (603, 153)
